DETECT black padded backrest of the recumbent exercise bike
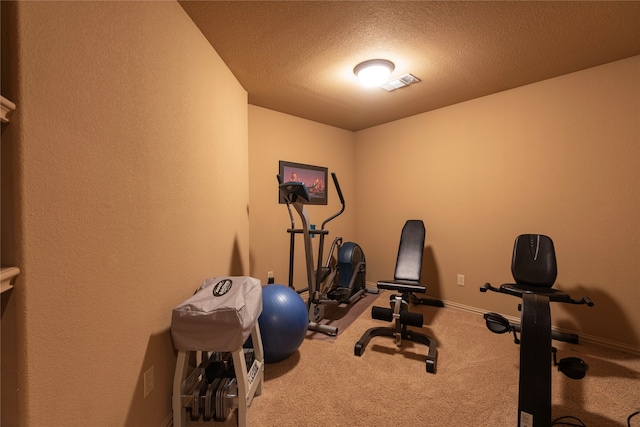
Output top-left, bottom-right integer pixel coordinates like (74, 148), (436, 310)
(511, 234), (558, 288)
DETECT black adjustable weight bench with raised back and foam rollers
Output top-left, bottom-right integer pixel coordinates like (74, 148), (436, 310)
(354, 220), (444, 374)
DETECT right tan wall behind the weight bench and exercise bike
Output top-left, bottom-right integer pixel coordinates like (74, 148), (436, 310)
(355, 56), (640, 348)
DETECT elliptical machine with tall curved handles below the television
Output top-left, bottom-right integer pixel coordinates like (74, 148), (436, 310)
(278, 172), (378, 336)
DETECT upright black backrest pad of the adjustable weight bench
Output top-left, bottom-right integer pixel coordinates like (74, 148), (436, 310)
(393, 219), (426, 283)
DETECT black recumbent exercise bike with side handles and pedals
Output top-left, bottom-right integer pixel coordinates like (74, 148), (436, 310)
(480, 234), (593, 427)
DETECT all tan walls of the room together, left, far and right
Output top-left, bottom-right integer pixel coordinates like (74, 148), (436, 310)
(2, 2), (640, 426)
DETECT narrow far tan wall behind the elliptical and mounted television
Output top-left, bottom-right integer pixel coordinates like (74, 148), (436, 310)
(249, 105), (356, 289)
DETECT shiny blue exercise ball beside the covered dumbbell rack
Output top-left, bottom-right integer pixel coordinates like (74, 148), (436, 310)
(258, 284), (309, 363)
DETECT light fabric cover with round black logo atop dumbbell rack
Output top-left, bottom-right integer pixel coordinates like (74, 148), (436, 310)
(171, 276), (262, 351)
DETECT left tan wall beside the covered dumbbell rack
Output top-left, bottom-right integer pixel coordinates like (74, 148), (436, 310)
(2, 2), (250, 427)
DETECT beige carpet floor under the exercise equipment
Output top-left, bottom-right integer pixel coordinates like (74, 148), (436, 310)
(187, 292), (640, 427)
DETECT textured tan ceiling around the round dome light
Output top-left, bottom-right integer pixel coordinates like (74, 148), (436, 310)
(180, 1), (640, 131)
